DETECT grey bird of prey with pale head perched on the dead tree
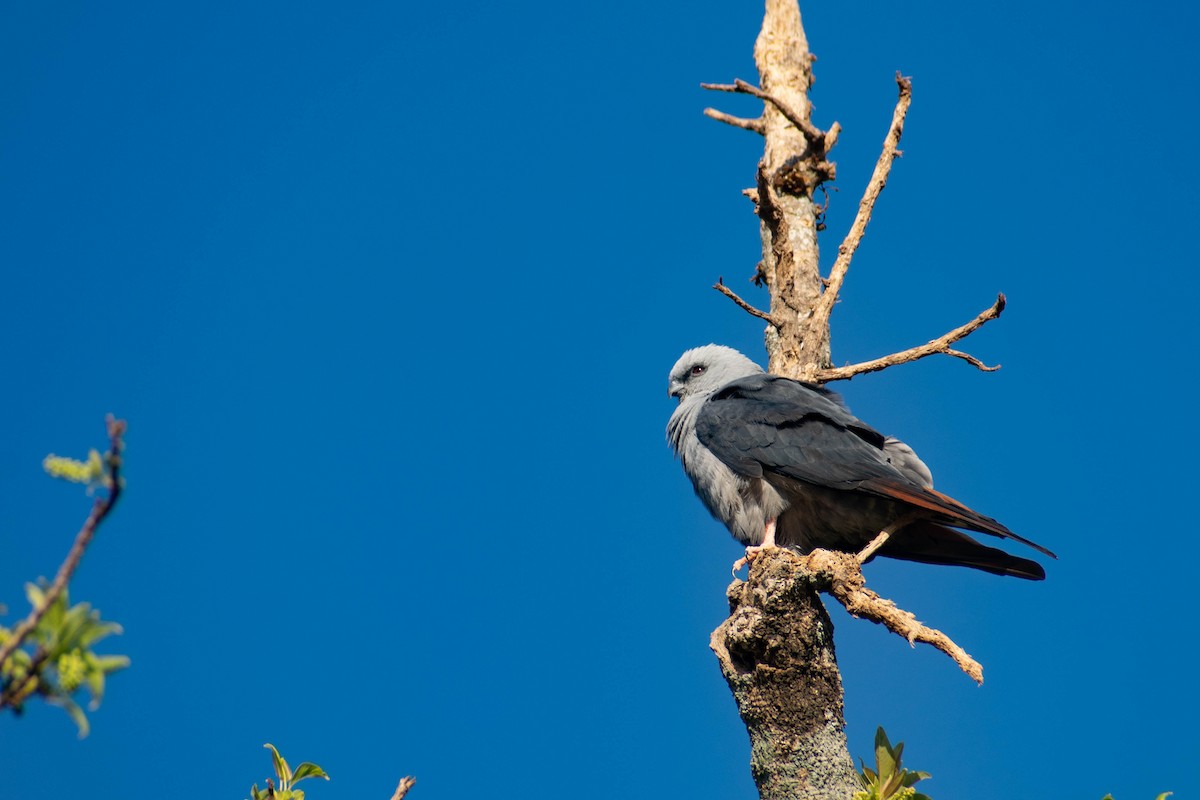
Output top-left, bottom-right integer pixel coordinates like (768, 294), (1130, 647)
(667, 344), (1057, 581)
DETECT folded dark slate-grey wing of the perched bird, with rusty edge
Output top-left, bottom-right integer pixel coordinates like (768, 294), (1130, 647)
(696, 375), (1054, 557)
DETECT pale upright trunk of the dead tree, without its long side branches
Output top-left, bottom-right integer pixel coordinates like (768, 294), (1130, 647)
(709, 0), (860, 800)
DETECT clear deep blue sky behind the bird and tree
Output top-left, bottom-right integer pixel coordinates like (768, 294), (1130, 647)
(0, 0), (1200, 800)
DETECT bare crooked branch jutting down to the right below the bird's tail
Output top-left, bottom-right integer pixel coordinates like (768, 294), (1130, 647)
(799, 549), (983, 684)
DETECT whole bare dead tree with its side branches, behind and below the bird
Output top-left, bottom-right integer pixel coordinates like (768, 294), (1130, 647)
(703, 0), (1004, 800)
